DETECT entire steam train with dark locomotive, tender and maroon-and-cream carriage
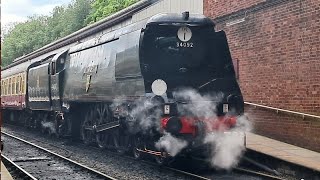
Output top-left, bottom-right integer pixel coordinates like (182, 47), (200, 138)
(1, 12), (243, 163)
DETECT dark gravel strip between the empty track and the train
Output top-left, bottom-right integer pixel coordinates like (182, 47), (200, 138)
(2, 127), (195, 180)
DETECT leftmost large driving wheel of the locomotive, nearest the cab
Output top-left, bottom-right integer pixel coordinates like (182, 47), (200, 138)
(80, 109), (94, 145)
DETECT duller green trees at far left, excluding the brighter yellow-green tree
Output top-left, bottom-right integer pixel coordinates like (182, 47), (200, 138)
(1, 0), (92, 66)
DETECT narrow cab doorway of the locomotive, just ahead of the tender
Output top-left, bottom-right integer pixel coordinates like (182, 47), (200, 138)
(50, 51), (67, 111)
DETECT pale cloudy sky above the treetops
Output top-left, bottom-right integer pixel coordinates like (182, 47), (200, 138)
(1, 0), (72, 26)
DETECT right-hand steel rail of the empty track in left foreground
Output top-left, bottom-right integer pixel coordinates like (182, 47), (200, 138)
(1, 131), (117, 180)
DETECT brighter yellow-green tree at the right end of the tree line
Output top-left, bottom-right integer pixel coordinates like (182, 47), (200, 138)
(86, 0), (139, 24)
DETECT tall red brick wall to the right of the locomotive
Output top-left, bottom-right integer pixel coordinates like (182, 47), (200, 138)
(204, 0), (320, 152)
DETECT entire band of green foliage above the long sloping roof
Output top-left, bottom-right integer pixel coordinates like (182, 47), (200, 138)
(1, 0), (138, 66)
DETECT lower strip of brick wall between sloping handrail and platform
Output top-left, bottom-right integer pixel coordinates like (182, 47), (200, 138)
(245, 106), (320, 152)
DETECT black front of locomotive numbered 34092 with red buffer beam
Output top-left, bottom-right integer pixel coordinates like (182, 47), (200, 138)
(134, 12), (244, 166)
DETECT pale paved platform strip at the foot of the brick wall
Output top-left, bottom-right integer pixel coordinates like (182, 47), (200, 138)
(246, 133), (320, 172)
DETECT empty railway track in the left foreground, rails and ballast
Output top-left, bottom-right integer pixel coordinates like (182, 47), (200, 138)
(2, 132), (116, 180)
